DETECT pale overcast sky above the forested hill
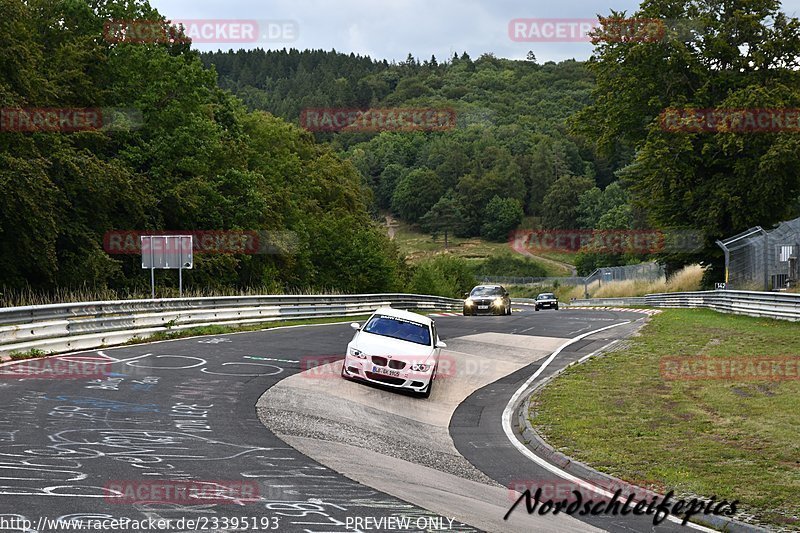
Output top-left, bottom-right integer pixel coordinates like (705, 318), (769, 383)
(151, 0), (800, 62)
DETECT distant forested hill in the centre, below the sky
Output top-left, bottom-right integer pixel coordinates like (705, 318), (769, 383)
(203, 50), (615, 241)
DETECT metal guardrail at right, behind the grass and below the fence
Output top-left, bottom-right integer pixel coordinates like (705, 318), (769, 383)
(570, 291), (800, 321)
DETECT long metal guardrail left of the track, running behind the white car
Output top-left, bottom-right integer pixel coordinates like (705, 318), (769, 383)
(0, 293), (463, 357)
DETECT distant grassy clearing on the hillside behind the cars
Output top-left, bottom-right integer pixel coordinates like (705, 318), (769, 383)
(394, 217), (570, 276)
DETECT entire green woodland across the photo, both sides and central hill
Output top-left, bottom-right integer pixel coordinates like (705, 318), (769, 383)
(0, 0), (800, 292)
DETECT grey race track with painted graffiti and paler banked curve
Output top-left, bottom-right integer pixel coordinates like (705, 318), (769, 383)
(0, 308), (700, 533)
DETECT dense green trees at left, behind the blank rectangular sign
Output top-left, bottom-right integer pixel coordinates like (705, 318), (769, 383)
(0, 0), (407, 292)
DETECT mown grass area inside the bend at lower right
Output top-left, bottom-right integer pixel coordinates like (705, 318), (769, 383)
(531, 309), (800, 530)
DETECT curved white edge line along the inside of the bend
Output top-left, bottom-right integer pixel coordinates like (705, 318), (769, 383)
(503, 321), (717, 533)
